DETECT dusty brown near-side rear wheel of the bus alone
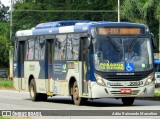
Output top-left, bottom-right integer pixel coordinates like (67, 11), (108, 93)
(29, 79), (39, 101)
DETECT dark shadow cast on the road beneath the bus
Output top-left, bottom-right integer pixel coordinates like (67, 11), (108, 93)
(25, 96), (160, 107)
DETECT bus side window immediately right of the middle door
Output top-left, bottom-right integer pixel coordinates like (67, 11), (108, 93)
(54, 35), (66, 60)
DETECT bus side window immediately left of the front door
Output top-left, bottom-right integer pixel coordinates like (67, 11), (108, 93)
(66, 34), (80, 60)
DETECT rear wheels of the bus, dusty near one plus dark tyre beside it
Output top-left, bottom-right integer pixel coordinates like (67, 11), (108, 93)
(29, 79), (47, 101)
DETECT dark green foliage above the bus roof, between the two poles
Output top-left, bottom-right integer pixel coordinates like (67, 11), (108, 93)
(13, 0), (117, 32)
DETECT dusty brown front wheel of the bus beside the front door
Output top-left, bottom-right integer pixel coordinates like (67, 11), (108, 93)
(72, 81), (88, 105)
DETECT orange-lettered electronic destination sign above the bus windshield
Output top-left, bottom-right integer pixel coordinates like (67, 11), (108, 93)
(97, 27), (144, 35)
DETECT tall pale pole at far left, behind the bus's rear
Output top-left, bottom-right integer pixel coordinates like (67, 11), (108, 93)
(9, 0), (13, 79)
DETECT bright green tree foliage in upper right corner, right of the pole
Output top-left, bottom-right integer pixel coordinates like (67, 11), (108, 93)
(121, 0), (160, 50)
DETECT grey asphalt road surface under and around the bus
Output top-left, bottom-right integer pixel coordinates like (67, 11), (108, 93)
(0, 90), (160, 119)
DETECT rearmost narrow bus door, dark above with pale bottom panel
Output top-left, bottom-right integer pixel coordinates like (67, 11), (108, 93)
(17, 41), (25, 90)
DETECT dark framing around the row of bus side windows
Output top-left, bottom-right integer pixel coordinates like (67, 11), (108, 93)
(14, 32), (89, 63)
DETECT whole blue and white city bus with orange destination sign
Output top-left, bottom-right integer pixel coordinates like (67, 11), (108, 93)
(13, 20), (155, 105)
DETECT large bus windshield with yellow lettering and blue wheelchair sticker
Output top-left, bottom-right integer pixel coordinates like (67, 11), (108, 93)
(93, 35), (153, 72)
